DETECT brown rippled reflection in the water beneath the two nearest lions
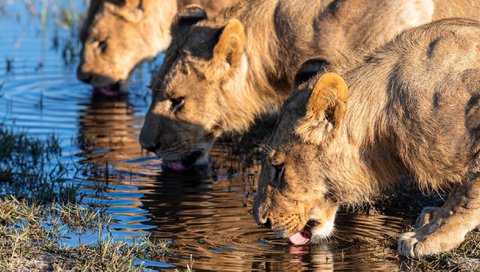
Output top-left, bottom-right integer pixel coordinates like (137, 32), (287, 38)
(142, 166), (401, 271)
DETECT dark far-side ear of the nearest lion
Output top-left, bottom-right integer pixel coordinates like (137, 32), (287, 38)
(292, 58), (334, 91)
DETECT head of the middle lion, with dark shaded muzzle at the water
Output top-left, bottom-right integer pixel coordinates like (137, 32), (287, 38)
(140, 7), (254, 170)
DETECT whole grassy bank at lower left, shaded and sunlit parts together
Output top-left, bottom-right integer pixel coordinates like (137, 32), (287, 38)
(0, 126), (188, 271)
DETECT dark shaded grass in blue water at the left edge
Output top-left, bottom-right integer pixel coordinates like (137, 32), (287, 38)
(0, 126), (78, 203)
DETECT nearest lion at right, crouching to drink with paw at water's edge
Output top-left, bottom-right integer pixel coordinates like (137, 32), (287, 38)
(254, 19), (480, 257)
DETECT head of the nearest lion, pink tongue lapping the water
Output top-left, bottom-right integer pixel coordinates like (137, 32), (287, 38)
(254, 61), (347, 244)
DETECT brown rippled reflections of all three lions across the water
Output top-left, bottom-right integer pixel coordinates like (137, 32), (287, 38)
(79, 95), (402, 271)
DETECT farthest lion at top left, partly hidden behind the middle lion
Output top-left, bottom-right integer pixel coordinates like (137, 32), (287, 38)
(77, 0), (238, 96)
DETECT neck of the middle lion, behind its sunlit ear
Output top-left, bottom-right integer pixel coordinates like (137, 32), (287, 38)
(218, 0), (348, 133)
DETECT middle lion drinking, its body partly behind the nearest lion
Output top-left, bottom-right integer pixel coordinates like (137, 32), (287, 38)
(140, 0), (480, 170)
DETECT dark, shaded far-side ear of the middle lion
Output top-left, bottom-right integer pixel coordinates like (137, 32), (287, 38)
(171, 5), (208, 39)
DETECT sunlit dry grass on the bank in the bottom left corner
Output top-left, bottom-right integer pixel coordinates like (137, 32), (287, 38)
(0, 197), (178, 271)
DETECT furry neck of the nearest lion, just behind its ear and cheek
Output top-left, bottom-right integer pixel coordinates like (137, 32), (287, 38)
(323, 67), (408, 205)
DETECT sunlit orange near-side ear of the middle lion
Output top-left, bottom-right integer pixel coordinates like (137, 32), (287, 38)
(213, 19), (245, 67)
